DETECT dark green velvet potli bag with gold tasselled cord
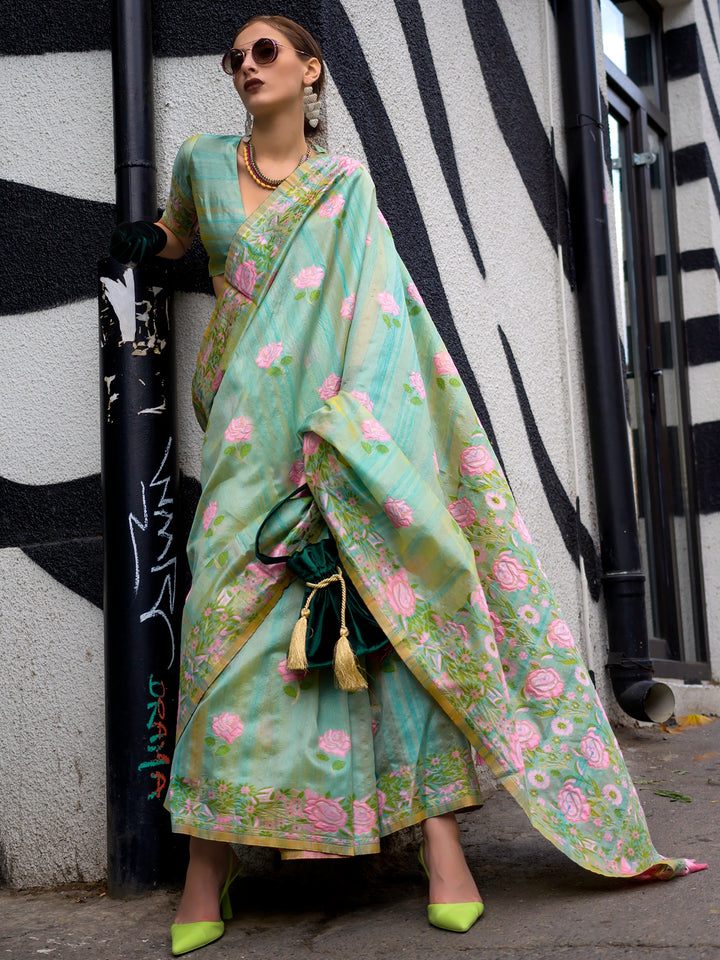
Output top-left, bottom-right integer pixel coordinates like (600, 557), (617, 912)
(255, 484), (388, 692)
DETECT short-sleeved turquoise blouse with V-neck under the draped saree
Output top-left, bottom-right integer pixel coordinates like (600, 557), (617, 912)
(161, 134), (245, 277)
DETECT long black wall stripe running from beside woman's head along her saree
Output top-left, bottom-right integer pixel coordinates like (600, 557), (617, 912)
(324, 4), (502, 464)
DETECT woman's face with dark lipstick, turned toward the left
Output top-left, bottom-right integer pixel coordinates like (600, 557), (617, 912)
(233, 22), (320, 117)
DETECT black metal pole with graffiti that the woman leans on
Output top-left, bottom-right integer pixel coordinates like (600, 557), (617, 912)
(99, 0), (181, 896)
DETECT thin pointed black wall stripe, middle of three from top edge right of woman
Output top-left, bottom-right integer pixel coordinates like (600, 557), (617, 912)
(395, 0), (485, 278)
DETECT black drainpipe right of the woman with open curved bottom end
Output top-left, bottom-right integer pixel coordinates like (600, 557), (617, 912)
(556, 0), (675, 722)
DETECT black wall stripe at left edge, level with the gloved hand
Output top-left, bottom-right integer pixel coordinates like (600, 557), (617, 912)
(0, 180), (115, 315)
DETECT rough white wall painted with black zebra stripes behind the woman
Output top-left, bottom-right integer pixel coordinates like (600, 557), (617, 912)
(0, 0), (720, 886)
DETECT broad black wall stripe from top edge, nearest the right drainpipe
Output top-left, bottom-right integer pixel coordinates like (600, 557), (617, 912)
(463, 0), (574, 287)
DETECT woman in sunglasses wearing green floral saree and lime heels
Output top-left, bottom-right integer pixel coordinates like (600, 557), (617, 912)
(113, 16), (704, 954)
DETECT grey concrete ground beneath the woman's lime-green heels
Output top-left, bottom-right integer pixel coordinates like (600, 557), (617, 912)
(0, 720), (720, 960)
